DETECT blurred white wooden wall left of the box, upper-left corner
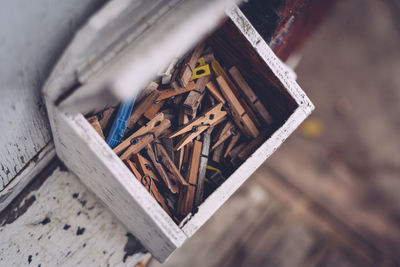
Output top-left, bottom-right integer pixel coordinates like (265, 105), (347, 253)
(0, 0), (105, 210)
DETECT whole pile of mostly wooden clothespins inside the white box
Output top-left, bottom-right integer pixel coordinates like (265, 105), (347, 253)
(87, 43), (272, 222)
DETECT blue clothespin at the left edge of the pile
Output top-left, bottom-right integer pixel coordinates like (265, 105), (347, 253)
(107, 98), (136, 148)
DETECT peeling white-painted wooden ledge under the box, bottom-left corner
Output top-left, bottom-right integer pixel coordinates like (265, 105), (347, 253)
(0, 160), (145, 266)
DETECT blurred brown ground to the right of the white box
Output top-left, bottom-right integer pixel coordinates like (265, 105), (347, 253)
(150, 0), (400, 267)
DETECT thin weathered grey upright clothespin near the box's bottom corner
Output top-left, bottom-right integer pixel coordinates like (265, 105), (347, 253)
(194, 132), (211, 207)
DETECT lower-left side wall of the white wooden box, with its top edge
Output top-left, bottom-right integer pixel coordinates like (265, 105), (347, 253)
(48, 104), (186, 261)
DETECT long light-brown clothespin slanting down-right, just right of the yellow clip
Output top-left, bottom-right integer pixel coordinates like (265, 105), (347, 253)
(217, 76), (260, 138)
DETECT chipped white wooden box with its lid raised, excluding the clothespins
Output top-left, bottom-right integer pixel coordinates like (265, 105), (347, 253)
(44, 0), (314, 262)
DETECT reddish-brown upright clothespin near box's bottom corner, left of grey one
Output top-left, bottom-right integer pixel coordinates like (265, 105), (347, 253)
(178, 140), (203, 216)
